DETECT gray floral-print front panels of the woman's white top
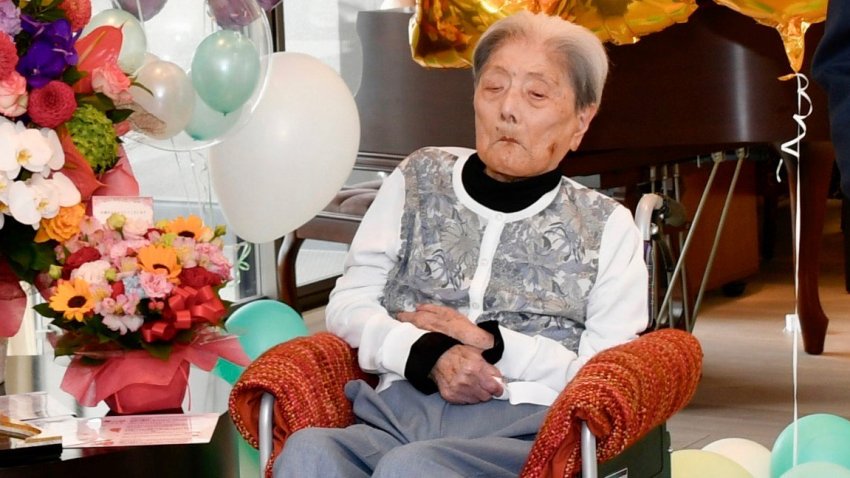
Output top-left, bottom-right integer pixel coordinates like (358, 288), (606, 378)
(382, 148), (618, 351)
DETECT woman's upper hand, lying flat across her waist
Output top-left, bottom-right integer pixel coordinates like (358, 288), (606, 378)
(397, 304), (493, 350)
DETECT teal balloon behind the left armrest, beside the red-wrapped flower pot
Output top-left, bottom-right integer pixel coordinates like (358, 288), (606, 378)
(213, 300), (310, 384)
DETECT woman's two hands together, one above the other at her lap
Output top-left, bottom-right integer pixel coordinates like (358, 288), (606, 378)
(397, 304), (504, 403)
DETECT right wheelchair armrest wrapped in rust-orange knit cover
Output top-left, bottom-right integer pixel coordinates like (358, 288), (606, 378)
(521, 329), (702, 476)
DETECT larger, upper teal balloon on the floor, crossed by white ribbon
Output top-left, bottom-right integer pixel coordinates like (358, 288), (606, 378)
(770, 413), (850, 478)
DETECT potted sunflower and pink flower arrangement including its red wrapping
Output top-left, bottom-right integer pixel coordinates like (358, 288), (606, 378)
(35, 214), (250, 413)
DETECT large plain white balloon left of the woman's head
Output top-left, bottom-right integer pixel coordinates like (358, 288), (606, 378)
(209, 52), (360, 243)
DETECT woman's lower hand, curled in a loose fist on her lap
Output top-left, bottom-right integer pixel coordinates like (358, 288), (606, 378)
(431, 345), (504, 404)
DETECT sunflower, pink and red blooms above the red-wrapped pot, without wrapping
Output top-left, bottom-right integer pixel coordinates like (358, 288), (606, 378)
(35, 214), (232, 362)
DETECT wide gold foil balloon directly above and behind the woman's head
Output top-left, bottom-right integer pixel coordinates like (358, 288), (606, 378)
(410, 0), (696, 68)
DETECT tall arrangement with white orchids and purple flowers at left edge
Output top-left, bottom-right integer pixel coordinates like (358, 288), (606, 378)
(0, 0), (139, 337)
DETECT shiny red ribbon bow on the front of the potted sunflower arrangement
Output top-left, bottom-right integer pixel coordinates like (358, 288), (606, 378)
(142, 285), (226, 342)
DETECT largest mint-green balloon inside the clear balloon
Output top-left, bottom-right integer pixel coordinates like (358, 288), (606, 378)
(192, 30), (260, 113)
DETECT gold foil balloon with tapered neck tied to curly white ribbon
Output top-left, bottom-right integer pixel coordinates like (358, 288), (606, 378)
(714, 0), (824, 72)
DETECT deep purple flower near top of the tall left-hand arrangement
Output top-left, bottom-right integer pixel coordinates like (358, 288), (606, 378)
(18, 15), (77, 88)
